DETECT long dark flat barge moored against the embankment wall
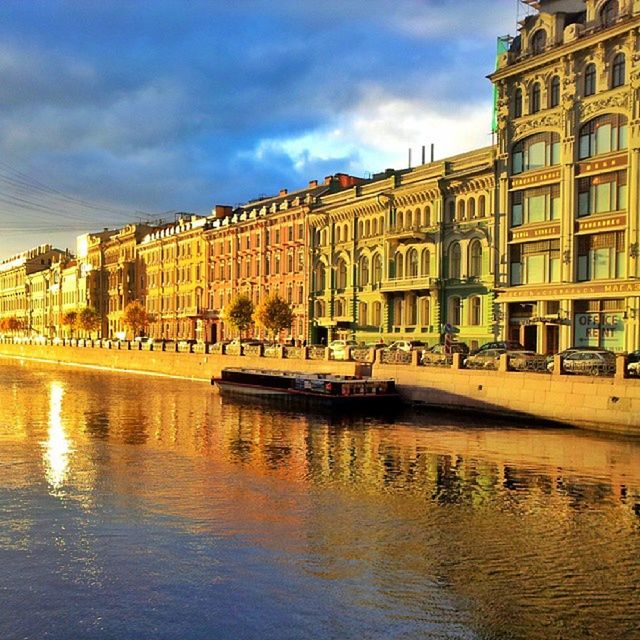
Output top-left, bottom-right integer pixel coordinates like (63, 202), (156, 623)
(211, 367), (400, 407)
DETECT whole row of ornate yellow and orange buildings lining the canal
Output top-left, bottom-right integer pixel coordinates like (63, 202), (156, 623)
(0, 0), (640, 353)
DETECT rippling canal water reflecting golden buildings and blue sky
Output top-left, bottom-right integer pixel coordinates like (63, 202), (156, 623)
(0, 359), (640, 640)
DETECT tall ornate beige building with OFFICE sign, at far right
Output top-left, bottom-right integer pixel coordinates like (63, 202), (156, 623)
(491, 0), (640, 352)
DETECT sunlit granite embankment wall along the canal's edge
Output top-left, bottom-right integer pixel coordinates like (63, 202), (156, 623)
(0, 343), (640, 436)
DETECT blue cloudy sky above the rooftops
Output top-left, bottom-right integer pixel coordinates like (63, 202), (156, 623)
(0, 0), (524, 260)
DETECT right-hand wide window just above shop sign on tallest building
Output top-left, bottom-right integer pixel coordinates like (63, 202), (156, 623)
(578, 231), (625, 281)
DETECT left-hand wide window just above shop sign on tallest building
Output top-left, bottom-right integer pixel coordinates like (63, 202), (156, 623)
(509, 240), (560, 285)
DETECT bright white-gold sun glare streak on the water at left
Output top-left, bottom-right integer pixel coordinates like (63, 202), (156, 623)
(43, 380), (71, 494)
